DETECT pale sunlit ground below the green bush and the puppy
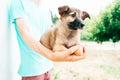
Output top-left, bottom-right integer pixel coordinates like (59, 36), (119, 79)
(51, 42), (120, 80)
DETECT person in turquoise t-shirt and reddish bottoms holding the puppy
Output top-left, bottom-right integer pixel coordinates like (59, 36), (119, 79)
(10, 0), (85, 80)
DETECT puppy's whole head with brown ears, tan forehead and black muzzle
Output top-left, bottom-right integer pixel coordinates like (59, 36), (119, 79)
(58, 5), (90, 30)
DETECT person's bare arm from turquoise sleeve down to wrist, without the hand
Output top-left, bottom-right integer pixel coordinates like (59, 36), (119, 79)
(16, 19), (52, 60)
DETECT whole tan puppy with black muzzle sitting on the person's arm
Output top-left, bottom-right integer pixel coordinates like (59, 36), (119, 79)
(40, 5), (90, 55)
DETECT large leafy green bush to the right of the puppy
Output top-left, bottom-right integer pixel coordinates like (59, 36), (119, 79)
(82, 0), (120, 43)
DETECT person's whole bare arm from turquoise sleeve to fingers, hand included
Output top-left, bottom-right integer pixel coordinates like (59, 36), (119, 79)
(16, 18), (85, 61)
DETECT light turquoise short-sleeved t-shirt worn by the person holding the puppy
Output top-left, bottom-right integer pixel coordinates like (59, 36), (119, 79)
(9, 0), (53, 76)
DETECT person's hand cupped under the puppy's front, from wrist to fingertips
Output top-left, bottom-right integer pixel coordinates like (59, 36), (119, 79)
(52, 46), (85, 62)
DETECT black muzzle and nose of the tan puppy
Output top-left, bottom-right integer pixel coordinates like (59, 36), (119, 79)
(68, 19), (84, 30)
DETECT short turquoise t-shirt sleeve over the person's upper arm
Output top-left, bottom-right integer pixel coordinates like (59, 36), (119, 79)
(9, 0), (25, 23)
